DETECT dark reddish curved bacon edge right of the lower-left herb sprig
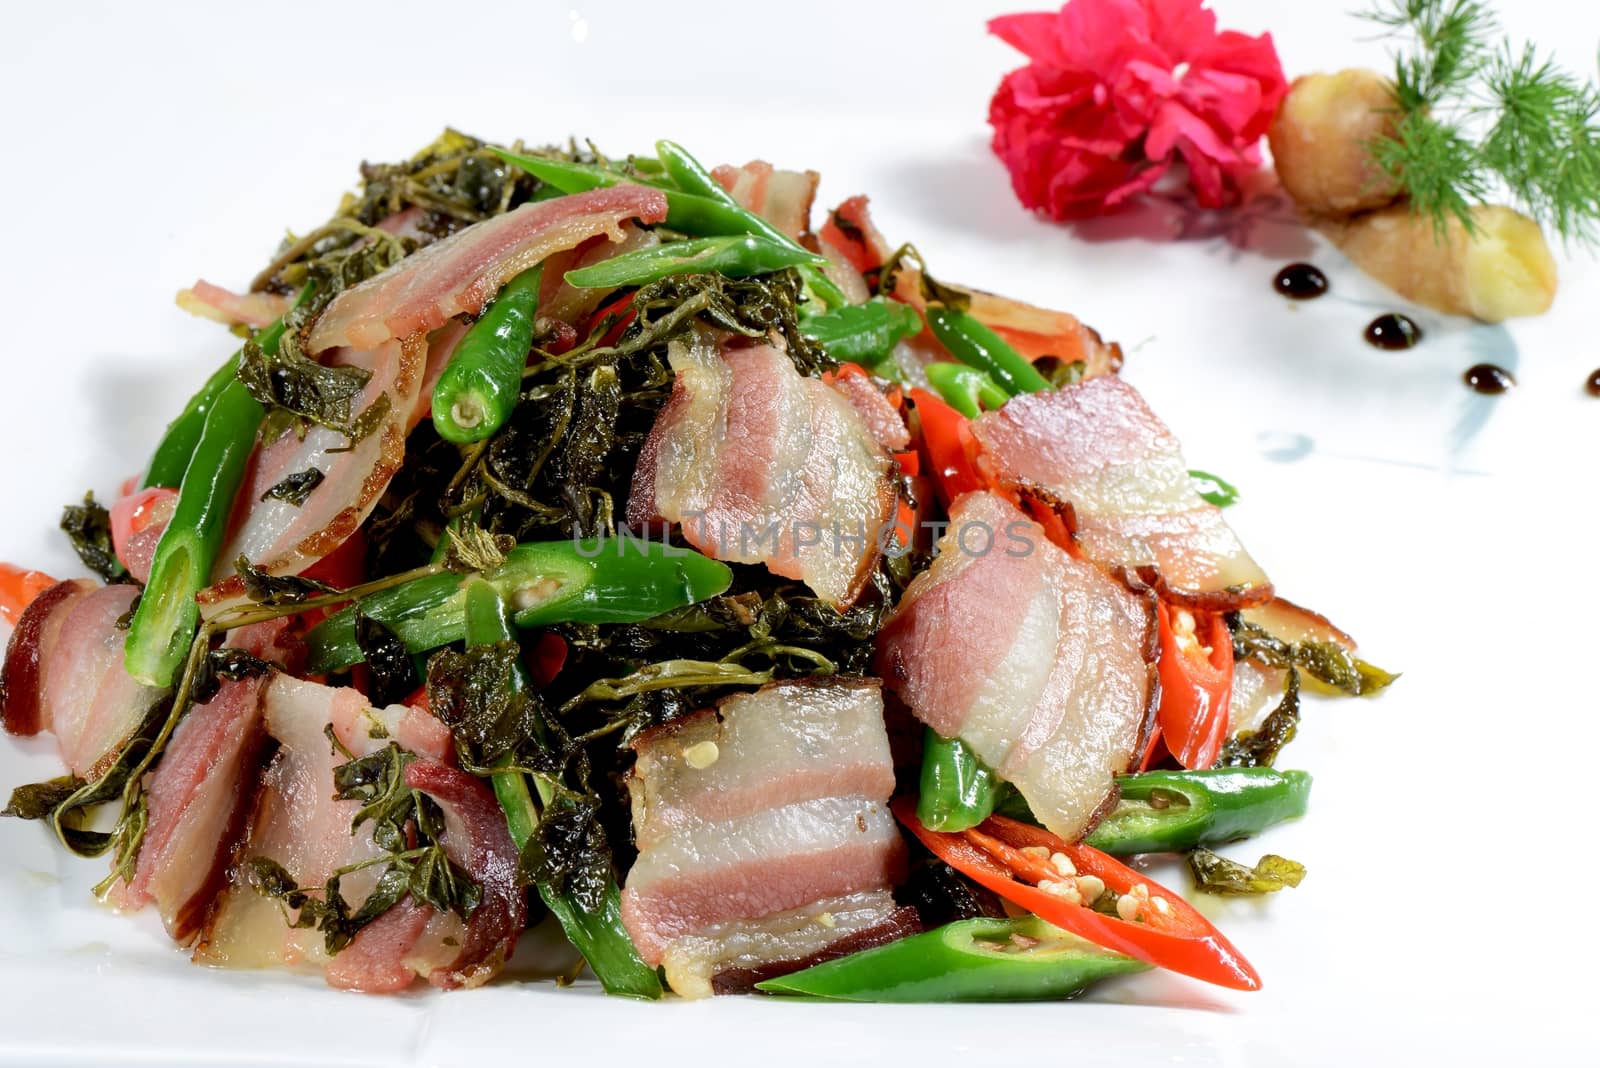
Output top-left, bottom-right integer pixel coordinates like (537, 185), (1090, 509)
(405, 759), (528, 990)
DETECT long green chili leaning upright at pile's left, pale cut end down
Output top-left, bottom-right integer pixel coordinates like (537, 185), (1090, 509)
(125, 381), (266, 686)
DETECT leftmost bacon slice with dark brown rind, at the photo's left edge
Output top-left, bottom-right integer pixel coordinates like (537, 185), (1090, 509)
(3, 579), (168, 780)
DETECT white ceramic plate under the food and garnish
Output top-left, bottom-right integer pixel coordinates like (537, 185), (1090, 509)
(0, 0), (1600, 1068)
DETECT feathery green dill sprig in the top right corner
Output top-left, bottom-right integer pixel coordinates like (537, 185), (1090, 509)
(1363, 0), (1600, 245)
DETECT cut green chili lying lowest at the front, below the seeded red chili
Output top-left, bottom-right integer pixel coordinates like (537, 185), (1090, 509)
(757, 916), (1150, 1002)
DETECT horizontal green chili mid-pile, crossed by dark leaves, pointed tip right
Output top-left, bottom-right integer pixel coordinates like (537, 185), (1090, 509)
(306, 537), (733, 675)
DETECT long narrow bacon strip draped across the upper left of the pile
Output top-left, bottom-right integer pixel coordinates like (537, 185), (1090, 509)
(307, 184), (667, 352)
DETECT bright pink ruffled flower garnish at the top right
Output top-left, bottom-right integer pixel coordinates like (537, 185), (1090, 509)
(989, 0), (1288, 219)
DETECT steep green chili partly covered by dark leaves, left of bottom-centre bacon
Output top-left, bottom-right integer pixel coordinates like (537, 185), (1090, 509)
(466, 579), (661, 998)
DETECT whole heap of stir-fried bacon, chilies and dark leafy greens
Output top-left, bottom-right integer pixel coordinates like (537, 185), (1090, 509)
(0, 133), (1389, 999)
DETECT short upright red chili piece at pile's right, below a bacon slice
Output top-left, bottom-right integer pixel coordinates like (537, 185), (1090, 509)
(1155, 604), (1234, 767)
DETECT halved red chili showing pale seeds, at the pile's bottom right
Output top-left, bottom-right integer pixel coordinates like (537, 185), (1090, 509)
(893, 796), (1261, 990)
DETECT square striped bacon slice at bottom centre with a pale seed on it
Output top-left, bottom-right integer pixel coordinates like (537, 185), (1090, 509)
(622, 681), (904, 996)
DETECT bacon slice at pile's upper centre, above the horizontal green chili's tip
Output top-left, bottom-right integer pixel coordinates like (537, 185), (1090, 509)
(627, 333), (894, 606)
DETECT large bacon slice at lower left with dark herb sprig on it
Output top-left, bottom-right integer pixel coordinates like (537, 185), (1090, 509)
(195, 676), (525, 993)
